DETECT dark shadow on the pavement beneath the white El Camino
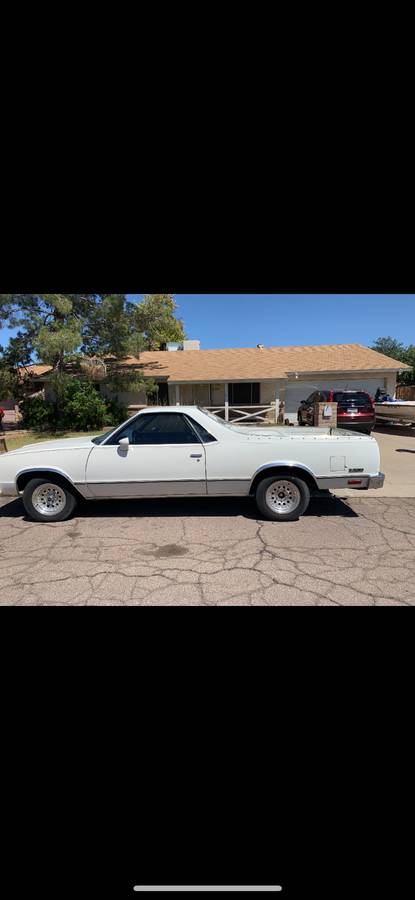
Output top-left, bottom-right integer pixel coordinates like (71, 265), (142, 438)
(0, 491), (358, 524)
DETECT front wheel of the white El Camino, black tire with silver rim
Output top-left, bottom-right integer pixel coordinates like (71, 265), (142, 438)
(23, 476), (77, 522)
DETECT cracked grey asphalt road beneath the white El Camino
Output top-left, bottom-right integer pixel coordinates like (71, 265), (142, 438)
(0, 495), (415, 606)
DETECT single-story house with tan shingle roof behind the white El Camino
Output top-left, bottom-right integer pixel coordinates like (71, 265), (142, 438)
(23, 341), (411, 421)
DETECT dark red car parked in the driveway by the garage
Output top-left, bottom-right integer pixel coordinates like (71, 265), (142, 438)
(297, 391), (376, 434)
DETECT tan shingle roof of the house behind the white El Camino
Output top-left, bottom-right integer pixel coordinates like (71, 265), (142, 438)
(112, 344), (410, 382)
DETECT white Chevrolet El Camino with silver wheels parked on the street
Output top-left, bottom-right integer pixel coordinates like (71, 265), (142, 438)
(0, 406), (384, 522)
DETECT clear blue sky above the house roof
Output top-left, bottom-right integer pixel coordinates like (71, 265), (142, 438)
(0, 294), (415, 350)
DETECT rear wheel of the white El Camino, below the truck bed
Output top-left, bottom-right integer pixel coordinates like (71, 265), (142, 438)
(255, 475), (310, 522)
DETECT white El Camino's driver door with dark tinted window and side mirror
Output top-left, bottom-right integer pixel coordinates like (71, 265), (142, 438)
(86, 412), (206, 498)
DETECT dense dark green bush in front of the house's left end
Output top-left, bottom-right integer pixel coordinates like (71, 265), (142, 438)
(20, 379), (127, 431)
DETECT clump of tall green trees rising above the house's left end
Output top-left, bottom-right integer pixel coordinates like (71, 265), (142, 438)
(0, 294), (184, 396)
